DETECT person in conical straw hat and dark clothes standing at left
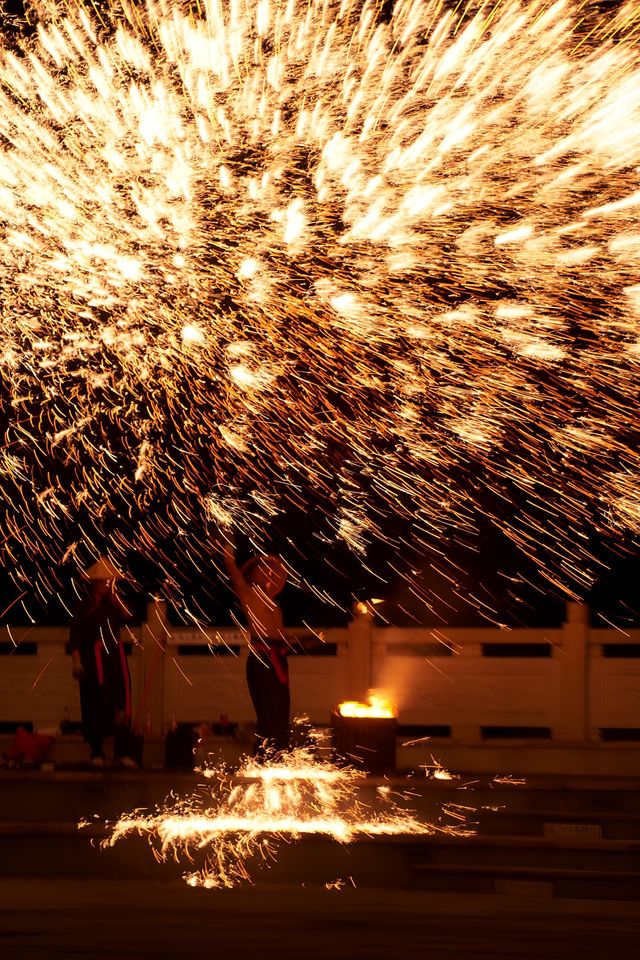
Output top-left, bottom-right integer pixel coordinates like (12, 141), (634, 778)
(68, 556), (137, 767)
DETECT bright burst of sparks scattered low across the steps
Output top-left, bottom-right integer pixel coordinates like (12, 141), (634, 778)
(99, 750), (473, 887)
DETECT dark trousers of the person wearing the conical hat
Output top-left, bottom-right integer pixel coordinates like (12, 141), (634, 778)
(80, 643), (131, 758)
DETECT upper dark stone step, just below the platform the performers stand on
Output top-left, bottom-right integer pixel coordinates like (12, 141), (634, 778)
(0, 769), (640, 824)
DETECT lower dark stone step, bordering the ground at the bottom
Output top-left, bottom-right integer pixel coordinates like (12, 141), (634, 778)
(0, 821), (640, 899)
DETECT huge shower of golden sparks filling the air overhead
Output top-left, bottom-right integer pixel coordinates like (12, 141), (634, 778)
(0, 0), (640, 616)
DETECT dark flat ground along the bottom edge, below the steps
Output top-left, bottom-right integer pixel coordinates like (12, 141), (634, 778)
(0, 878), (640, 960)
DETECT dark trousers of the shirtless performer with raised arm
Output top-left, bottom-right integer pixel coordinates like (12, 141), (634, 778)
(247, 644), (291, 754)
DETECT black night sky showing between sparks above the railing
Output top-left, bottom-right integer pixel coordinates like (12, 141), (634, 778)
(0, 0), (640, 629)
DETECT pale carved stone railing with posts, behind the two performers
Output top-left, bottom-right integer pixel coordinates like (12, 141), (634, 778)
(0, 604), (640, 744)
